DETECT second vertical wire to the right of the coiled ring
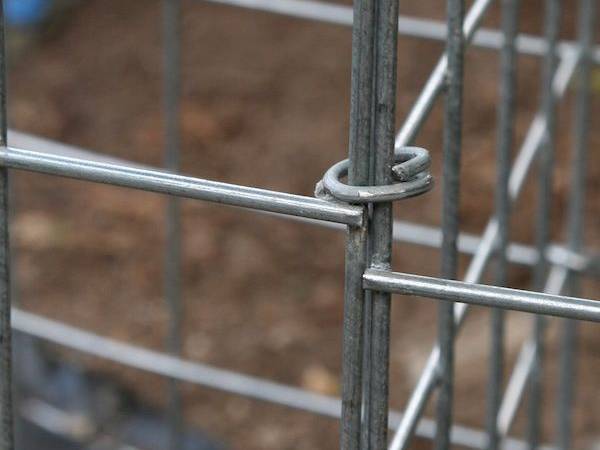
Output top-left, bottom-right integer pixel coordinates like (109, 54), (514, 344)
(487, 0), (519, 450)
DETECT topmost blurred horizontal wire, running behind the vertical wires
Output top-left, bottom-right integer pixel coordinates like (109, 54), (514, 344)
(196, 0), (600, 64)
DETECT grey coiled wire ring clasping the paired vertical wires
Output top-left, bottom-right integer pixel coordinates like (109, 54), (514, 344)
(315, 147), (433, 204)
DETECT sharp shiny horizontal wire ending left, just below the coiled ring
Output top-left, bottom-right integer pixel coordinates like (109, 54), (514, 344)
(0, 147), (363, 226)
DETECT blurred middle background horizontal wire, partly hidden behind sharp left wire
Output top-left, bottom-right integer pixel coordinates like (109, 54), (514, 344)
(8, 130), (600, 275)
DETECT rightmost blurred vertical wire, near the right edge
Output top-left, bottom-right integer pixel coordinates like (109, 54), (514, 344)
(556, 0), (598, 450)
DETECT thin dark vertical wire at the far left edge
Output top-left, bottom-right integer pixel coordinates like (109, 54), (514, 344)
(0, 0), (14, 450)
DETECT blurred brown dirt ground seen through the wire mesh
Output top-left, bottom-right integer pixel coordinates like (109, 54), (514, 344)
(4, 0), (600, 450)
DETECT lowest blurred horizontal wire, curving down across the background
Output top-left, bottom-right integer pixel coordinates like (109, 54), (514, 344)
(12, 308), (552, 450)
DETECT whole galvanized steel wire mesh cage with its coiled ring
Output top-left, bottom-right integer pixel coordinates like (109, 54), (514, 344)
(0, 0), (600, 450)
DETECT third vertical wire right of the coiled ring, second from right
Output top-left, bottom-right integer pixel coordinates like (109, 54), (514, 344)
(527, 0), (561, 449)
